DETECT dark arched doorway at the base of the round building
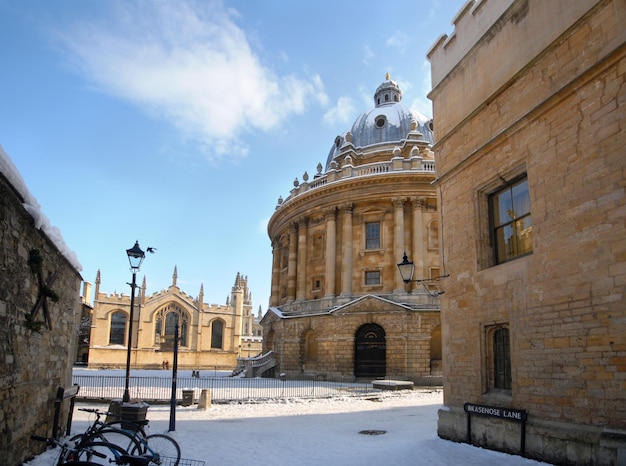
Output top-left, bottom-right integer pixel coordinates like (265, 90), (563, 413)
(354, 324), (387, 377)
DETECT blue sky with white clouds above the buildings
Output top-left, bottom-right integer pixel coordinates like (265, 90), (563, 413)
(0, 0), (465, 312)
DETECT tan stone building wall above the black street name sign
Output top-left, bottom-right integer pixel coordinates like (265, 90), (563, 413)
(431, 0), (626, 464)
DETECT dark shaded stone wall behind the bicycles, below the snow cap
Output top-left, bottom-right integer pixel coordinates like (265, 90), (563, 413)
(0, 174), (81, 466)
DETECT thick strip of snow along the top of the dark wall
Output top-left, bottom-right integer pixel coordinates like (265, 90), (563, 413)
(0, 145), (83, 272)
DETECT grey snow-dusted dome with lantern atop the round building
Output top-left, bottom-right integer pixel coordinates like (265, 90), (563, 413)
(326, 74), (433, 170)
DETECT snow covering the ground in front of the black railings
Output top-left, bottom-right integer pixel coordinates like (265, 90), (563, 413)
(26, 371), (544, 466)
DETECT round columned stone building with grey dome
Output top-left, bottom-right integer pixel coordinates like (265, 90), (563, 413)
(261, 76), (441, 383)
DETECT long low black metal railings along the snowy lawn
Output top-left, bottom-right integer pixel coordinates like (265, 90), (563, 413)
(73, 374), (380, 403)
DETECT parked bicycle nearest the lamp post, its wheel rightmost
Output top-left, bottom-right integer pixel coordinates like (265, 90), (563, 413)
(72, 408), (181, 466)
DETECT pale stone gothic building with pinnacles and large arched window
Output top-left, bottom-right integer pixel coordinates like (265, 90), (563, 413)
(89, 268), (263, 370)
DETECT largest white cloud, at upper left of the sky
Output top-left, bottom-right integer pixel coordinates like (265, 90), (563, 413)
(59, 0), (327, 158)
